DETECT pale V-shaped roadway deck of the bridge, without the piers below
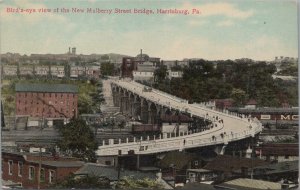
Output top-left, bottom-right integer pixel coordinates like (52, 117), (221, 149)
(97, 80), (262, 156)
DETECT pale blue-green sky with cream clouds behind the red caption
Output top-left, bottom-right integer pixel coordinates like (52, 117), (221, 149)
(0, 0), (298, 60)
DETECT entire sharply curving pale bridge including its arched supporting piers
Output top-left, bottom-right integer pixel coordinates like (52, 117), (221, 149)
(96, 79), (262, 156)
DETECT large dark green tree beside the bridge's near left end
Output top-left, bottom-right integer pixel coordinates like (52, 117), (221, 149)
(58, 118), (98, 162)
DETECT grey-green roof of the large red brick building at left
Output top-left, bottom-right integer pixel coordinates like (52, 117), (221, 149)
(15, 83), (78, 93)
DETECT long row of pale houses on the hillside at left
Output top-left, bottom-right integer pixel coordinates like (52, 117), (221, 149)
(1, 64), (100, 78)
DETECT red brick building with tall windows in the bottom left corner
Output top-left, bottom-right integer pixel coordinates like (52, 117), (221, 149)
(2, 152), (84, 189)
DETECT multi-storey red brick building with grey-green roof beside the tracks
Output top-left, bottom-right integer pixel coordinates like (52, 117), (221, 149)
(15, 84), (78, 118)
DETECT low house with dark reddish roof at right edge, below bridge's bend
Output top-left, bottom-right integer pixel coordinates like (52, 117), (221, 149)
(255, 143), (299, 162)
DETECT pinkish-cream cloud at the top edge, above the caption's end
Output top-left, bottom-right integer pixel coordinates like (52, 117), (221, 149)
(182, 3), (254, 19)
